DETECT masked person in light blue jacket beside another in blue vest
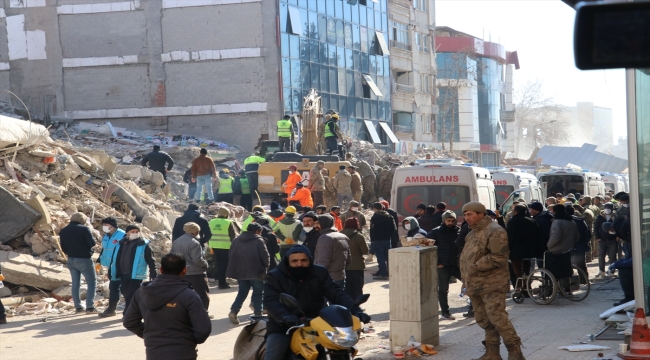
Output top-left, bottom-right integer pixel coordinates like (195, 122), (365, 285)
(97, 217), (126, 317)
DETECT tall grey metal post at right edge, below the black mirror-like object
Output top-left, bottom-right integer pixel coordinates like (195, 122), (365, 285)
(625, 69), (645, 310)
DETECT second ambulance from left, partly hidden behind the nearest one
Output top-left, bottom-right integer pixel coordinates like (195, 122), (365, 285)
(490, 168), (546, 205)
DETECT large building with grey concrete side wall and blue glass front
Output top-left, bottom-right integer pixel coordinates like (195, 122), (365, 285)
(0, 0), (394, 150)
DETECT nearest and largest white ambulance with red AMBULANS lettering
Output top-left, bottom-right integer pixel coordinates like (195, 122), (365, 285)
(391, 160), (496, 221)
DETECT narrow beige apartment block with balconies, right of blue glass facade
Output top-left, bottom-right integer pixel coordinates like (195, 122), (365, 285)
(388, 0), (438, 153)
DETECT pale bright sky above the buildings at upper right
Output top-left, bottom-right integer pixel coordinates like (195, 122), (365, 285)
(436, 0), (627, 143)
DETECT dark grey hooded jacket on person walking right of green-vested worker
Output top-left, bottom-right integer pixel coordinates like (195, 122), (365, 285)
(226, 231), (269, 280)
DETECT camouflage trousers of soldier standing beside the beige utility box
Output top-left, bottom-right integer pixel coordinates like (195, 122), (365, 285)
(469, 292), (521, 345)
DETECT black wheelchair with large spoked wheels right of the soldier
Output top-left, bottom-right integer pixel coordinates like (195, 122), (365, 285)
(512, 252), (591, 305)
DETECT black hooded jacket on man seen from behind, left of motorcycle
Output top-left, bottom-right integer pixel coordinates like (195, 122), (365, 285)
(122, 274), (212, 359)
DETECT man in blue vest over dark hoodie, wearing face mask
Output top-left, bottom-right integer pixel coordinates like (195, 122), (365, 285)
(109, 224), (156, 314)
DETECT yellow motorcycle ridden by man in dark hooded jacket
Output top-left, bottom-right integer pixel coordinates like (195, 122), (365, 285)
(280, 294), (370, 360)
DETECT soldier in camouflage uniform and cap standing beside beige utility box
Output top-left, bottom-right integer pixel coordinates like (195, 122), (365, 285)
(460, 202), (525, 360)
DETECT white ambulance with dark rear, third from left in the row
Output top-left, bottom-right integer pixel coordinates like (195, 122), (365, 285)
(537, 169), (605, 198)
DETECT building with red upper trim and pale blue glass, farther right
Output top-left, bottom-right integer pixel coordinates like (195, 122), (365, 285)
(434, 27), (519, 166)
